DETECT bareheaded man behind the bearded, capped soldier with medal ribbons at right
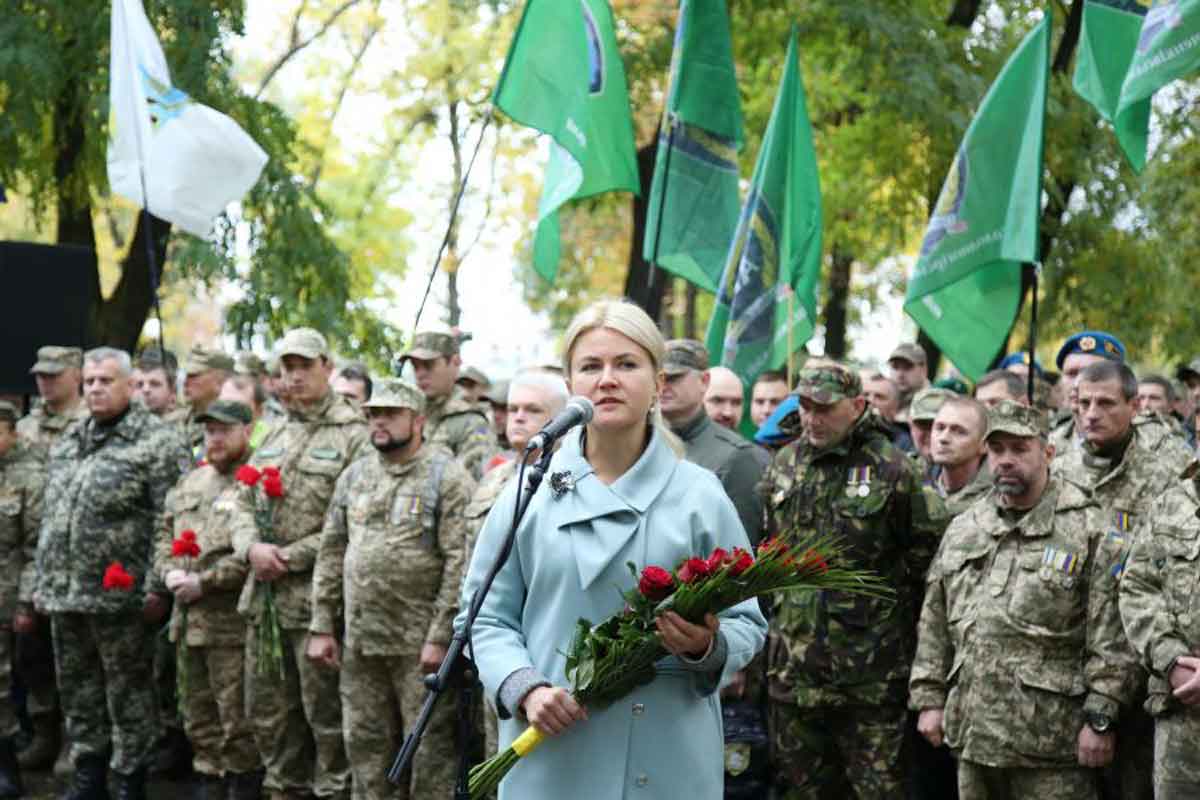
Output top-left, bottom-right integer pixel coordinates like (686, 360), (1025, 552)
(930, 397), (991, 517)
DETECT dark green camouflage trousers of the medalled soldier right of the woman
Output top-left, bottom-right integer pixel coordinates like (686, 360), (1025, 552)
(768, 700), (907, 800)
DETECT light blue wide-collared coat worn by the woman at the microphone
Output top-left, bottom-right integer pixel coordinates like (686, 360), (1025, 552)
(456, 433), (767, 800)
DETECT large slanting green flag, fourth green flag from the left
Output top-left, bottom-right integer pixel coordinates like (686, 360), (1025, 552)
(904, 11), (1050, 380)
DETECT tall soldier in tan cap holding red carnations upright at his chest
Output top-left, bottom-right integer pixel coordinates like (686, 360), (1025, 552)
(230, 327), (366, 798)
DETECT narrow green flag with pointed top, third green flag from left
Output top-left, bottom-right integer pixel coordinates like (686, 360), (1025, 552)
(707, 26), (821, 386)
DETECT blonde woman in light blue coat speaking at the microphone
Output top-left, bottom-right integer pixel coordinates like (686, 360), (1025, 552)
(458, 301), (767, 800)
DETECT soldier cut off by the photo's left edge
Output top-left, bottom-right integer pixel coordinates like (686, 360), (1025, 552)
(0, 401), (46, 798)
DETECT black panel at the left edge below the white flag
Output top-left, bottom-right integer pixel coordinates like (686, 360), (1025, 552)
(0, 241), (100, 395)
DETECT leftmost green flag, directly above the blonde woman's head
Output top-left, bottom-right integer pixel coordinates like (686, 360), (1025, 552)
(492, 0), (640, 282)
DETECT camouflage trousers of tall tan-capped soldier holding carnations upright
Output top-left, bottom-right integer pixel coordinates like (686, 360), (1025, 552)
(245, 625), (350, 798)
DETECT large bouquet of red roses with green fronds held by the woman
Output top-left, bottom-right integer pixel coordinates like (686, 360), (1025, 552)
(470, 537), (888, 800)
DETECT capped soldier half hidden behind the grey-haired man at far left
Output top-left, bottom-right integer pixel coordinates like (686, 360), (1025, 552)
(16, 345), (88, 769)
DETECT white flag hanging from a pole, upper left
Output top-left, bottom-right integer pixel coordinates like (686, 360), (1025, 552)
(108, 0), (266, 236)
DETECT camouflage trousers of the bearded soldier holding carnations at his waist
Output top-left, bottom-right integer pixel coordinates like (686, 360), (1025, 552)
(180, 648), (260, 776)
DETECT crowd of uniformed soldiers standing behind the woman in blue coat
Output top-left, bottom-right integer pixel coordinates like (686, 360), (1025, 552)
(7, 321), (1200, 800)
